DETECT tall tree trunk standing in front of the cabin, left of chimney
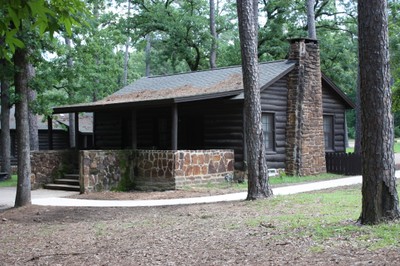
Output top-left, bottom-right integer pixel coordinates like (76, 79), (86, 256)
(237, 0), (272, 200)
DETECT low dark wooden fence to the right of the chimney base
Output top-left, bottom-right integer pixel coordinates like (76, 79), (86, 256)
(325, 152), (361, 175)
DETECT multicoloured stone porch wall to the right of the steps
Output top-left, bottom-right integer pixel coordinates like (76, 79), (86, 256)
(80, 150), (234, 193)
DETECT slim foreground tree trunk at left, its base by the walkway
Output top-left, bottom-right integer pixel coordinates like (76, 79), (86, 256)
(14, 49), (31, 207)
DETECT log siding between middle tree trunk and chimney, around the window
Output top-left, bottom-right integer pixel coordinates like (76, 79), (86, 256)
(261, 77), (287, 168)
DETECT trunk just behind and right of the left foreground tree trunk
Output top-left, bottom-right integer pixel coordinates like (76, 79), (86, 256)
(28, 61), (39, 151)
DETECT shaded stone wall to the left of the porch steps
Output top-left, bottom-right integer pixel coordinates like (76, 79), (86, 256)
(30, 150), (79, 189)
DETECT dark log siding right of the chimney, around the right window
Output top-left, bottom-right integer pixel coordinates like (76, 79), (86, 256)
(322, 84), (346, 152)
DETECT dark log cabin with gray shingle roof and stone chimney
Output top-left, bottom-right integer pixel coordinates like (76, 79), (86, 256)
(53, 38), (354, 175)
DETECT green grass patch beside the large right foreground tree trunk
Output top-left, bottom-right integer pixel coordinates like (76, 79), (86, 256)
(244, 185), (400, 252)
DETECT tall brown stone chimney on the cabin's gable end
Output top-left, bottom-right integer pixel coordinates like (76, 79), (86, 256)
(286, 38), (326, 176)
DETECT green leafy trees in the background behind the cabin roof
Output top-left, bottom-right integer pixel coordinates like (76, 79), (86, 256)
(0, 0), (400, 137)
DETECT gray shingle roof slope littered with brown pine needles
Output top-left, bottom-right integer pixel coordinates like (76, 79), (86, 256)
(54, 60), (295, 113)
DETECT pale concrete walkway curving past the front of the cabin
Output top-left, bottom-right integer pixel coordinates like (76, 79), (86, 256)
(0, 171), (400, 209)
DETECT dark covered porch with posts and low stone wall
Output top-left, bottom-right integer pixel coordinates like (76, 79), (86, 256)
(38, 95), (244, 193)
